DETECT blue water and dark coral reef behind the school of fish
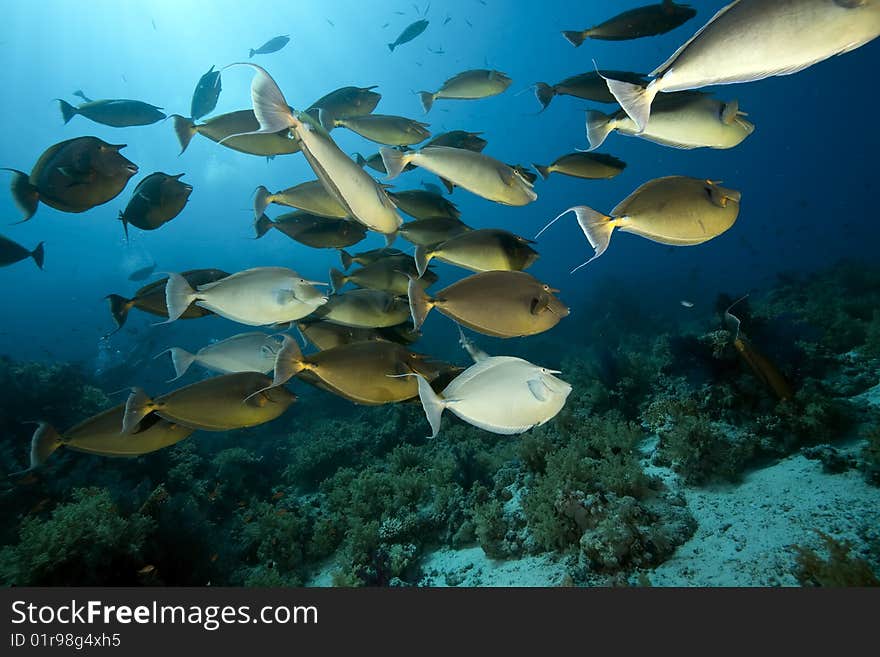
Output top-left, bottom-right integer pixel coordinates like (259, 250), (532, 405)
(0, 0), (880, 586)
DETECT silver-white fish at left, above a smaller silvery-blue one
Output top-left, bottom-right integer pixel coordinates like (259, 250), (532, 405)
(162, 267), (327, 326)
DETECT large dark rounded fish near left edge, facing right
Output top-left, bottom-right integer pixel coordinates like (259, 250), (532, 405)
(2, 137), (138, 221)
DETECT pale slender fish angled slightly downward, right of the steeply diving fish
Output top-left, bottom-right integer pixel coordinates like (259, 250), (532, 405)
(379, 146), (538, 205)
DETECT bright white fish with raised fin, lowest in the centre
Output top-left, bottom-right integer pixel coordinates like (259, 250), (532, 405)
(415, 334), (571, 438)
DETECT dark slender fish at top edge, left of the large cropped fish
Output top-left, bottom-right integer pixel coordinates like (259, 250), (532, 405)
(562, 0), (697, 48)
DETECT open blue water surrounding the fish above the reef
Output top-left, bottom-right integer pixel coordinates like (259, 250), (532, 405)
(0, 0), (880, 584)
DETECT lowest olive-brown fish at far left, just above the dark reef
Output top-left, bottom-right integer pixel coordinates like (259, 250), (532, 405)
(29, 404), (195, 470)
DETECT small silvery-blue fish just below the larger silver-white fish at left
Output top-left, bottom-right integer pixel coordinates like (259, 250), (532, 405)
(156, 331), (281, 381)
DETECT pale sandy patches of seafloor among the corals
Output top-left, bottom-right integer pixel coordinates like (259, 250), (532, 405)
(308, 384), (880, 587)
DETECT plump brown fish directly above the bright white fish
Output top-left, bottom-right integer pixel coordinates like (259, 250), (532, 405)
(409, 271), (569, 338)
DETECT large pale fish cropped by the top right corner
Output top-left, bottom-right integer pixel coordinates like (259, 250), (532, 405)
(607, 0), (880, 131)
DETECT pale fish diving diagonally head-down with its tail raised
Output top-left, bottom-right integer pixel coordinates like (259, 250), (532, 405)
(221, 63), (403, 236)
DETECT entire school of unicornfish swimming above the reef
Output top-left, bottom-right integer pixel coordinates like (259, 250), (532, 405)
(6, 0), (880, 469)
